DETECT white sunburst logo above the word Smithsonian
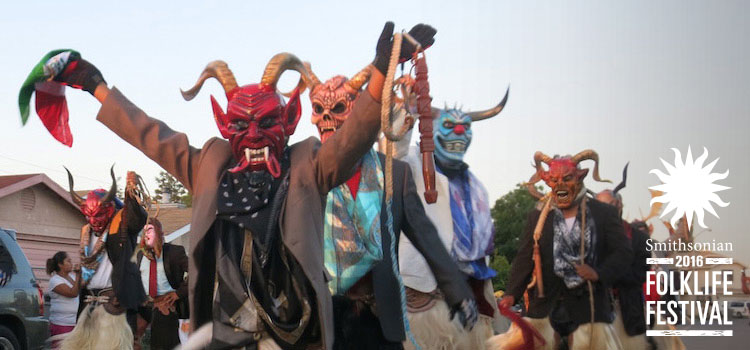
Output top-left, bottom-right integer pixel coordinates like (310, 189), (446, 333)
(649, 146), (730, 229)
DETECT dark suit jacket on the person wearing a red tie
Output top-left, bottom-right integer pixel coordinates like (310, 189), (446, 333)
(136, 243), (189, 318)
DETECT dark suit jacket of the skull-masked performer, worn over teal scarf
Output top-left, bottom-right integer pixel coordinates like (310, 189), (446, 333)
(372, 153), (473, 342)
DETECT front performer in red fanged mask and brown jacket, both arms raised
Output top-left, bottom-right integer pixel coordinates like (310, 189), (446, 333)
(42, 22), (435, 349)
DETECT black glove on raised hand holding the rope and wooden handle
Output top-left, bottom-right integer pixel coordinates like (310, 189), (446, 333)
(372, 21), (437, 75)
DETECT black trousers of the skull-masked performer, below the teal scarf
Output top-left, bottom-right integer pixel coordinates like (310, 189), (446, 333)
(333, 295), (404, 350)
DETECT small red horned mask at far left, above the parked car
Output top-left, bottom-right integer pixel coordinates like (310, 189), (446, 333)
(65, 166), (117, 233)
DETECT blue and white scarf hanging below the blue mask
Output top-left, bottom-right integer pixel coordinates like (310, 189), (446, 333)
(448, 169), (497, 280)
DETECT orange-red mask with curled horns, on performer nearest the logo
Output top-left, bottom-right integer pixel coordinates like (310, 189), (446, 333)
(526, 149), (611, 209)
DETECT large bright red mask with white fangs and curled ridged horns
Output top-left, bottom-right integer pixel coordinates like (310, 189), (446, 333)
(182, 53), (307, 178)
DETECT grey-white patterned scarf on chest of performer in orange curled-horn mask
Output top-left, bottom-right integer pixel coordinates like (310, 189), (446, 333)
(552, 204), (596, 288)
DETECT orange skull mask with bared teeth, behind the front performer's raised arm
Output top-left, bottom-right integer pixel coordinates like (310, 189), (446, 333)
(306, 63), (370, 142)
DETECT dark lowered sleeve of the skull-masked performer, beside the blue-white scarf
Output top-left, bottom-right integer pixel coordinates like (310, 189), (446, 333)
(402, 166), (473, 306)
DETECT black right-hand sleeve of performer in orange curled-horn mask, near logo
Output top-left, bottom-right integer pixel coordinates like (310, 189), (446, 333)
(594, 206), (632, 286)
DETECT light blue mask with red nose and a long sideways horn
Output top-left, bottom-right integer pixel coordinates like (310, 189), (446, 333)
(432, 88), (510, 168)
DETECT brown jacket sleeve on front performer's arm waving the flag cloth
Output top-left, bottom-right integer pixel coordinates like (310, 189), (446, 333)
(96, 88), (200, 191)
